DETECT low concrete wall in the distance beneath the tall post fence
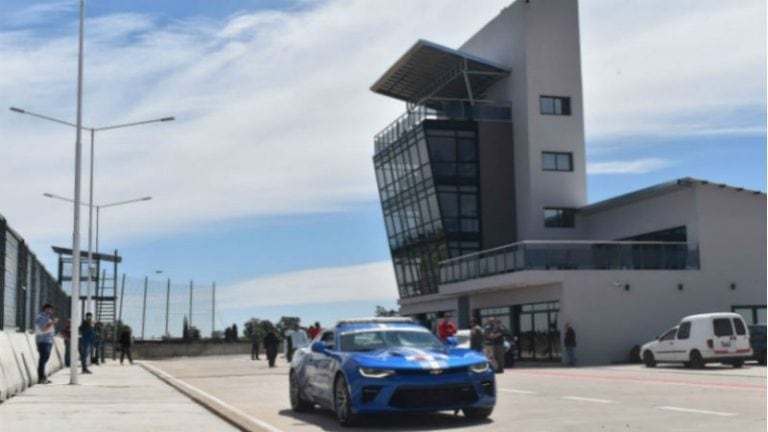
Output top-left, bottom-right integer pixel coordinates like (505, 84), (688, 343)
(131, 341), (264, 359)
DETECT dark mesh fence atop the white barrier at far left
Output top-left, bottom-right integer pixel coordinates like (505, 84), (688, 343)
(0, 216), (70, 331)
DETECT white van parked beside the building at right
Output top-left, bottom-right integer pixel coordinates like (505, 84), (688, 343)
(640, 313), (752, 368)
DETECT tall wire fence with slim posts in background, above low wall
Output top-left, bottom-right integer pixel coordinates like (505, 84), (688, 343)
(117, 275), (216, 340)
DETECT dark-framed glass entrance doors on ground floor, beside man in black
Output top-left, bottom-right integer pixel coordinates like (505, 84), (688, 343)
(514, 302), (560, 361)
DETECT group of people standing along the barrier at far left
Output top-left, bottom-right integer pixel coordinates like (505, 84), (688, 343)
(35, 304), (133, 384)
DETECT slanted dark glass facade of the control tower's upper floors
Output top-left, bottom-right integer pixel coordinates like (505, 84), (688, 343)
(374, 120), (481, 298)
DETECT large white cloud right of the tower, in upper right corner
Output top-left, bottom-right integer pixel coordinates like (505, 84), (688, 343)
(581, 0), (766, 139)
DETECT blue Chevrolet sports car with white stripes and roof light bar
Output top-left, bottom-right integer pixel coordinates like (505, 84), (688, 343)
(289, 318), (496, 426)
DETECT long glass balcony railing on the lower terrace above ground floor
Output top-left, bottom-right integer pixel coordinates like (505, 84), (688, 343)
(440, 241), (699, 284)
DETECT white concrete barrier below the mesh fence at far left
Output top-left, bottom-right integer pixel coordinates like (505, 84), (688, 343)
(0, 331), (64, 401)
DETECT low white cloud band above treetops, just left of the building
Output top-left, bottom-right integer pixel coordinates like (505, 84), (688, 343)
(216, 261), (397, 310)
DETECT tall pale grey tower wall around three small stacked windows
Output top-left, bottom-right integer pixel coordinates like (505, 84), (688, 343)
(460, 0), (587, 240)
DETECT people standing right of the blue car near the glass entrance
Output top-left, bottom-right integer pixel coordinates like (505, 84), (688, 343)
(437, 313), (576, 373)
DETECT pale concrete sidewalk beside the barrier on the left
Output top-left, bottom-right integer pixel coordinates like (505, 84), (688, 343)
(0, 361), (237, 432)
